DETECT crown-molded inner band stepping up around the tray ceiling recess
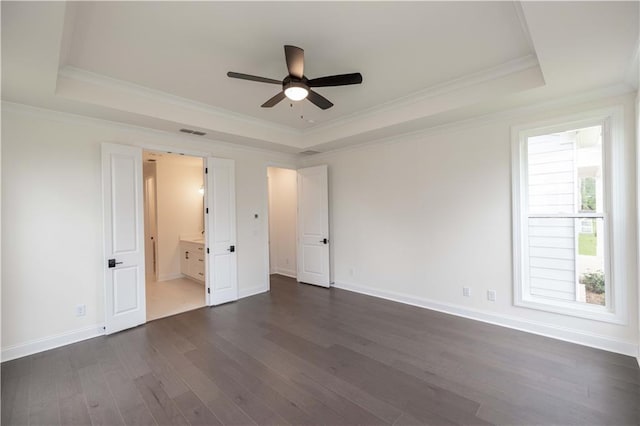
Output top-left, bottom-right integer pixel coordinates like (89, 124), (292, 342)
(56, 55), (541, 151)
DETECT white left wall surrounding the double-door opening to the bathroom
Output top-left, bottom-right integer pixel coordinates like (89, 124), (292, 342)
(1, 103), (295, 360)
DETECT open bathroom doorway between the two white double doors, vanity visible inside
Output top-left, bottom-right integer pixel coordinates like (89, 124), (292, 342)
(143, 151), (207, 321)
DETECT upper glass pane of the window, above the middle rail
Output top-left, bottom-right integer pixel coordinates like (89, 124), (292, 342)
(527, 126), (603, 215)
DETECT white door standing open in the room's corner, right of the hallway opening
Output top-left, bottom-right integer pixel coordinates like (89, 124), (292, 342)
(297, 165), (330, 287)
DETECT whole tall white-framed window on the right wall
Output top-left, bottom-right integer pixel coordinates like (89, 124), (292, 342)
(513, 109), (624, 322)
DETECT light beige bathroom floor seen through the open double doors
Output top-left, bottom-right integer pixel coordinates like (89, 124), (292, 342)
(146, 278), (206, 321)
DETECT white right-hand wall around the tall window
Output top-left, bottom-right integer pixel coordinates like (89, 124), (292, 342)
(306, 95), (638, 353)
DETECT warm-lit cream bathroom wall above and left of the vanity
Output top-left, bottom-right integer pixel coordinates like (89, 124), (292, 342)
(156, 155), (204, 281)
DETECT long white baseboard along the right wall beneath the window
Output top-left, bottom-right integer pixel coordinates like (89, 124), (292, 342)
(333, 282), (640, 358)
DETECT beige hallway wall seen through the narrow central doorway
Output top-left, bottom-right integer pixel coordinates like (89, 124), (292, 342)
(267, 167), (298, 277)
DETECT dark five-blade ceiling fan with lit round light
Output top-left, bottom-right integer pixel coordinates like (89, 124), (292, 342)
(227, 45), (362, 109)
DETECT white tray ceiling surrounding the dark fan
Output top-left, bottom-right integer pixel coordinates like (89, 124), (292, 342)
(2, 1), (638, 152)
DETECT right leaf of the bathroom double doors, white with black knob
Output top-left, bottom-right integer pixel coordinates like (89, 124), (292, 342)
(206, 158), (238, 305)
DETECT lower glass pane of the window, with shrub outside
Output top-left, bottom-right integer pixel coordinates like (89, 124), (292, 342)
(528, 218), (605, 305)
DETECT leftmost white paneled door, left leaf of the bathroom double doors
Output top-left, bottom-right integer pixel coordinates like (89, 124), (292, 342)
(102, 143), (146, 334)
